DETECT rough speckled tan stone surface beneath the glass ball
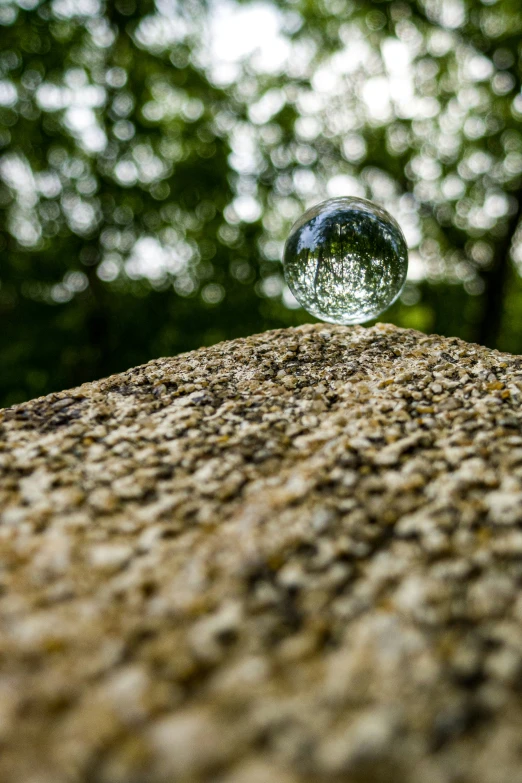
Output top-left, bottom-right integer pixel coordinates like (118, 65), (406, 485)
(0, 325), (522, 783)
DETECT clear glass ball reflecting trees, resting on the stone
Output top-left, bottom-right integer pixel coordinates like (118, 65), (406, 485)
(283, 197), (408, 324)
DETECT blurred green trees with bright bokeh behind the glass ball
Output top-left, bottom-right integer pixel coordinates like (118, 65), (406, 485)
(0, 0), (522, 405)
